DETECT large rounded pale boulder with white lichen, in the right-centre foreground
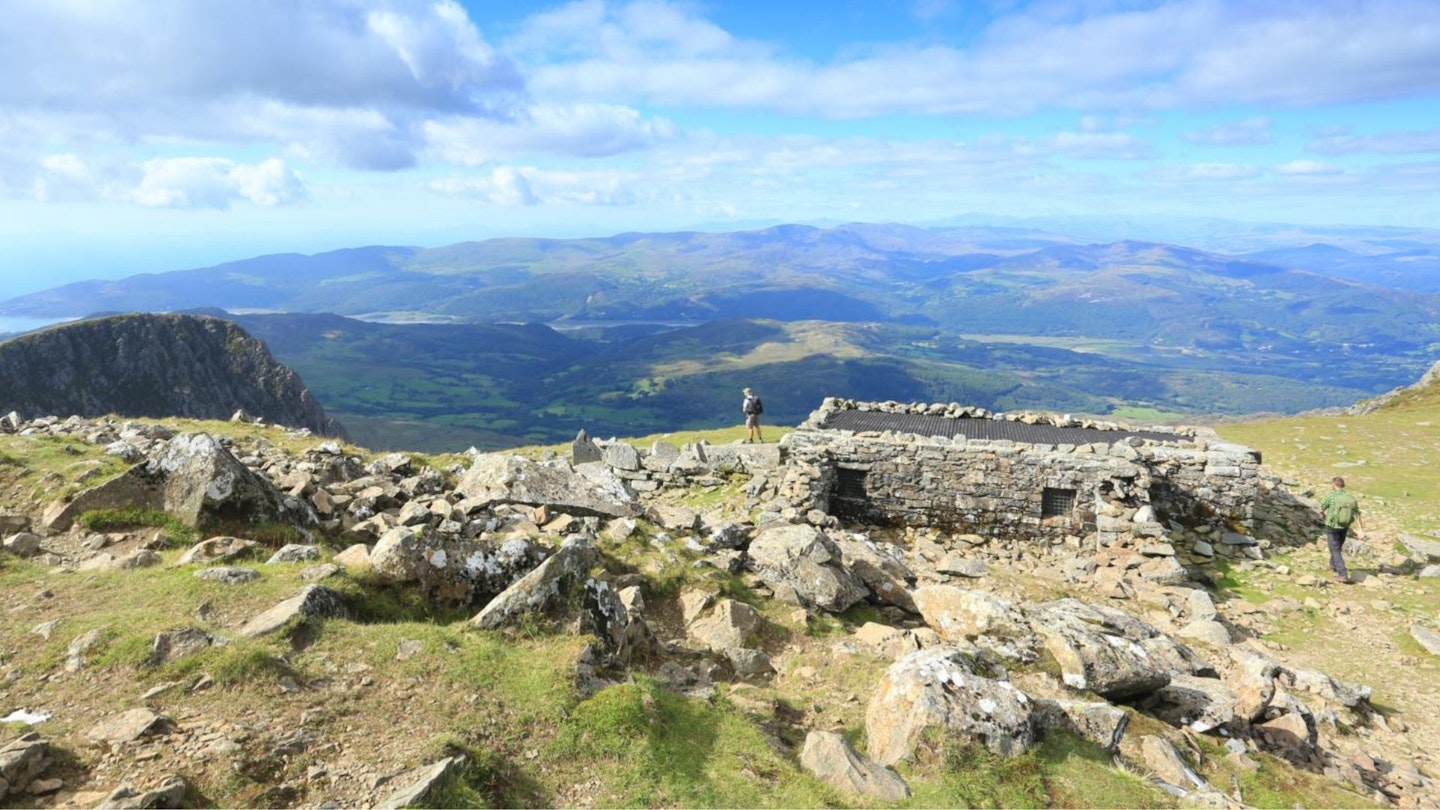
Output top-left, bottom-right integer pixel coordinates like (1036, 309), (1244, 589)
(865, 646), (1034, 765)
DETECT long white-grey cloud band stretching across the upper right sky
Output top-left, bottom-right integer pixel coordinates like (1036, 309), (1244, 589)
(505, 0), (1440, 118)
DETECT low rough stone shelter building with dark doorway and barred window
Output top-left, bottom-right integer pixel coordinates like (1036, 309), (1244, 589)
(780, 398), (1261, 545)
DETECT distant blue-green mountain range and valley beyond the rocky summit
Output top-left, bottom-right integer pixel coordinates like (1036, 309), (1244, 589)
(0, 223), (1440, 450)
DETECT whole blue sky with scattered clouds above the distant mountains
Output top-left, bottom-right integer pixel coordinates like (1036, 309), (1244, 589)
(0, 0), (1440, 294)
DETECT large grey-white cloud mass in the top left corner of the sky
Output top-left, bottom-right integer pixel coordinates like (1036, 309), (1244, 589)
(0, 0), (527, 177)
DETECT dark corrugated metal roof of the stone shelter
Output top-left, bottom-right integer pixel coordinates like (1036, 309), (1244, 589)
(821, 411), (1184, 444)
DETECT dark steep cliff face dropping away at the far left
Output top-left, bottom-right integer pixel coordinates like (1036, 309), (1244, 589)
(0, 314), (346, 437)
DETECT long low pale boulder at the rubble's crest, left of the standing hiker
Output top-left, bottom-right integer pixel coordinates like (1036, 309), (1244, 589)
(455, 453), (639, 517)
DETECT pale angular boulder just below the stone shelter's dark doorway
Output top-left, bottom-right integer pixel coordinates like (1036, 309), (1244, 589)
(749, 525), (868, 613)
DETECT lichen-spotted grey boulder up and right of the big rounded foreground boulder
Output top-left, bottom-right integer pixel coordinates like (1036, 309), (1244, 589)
(1030, 600), (1171, 700)
